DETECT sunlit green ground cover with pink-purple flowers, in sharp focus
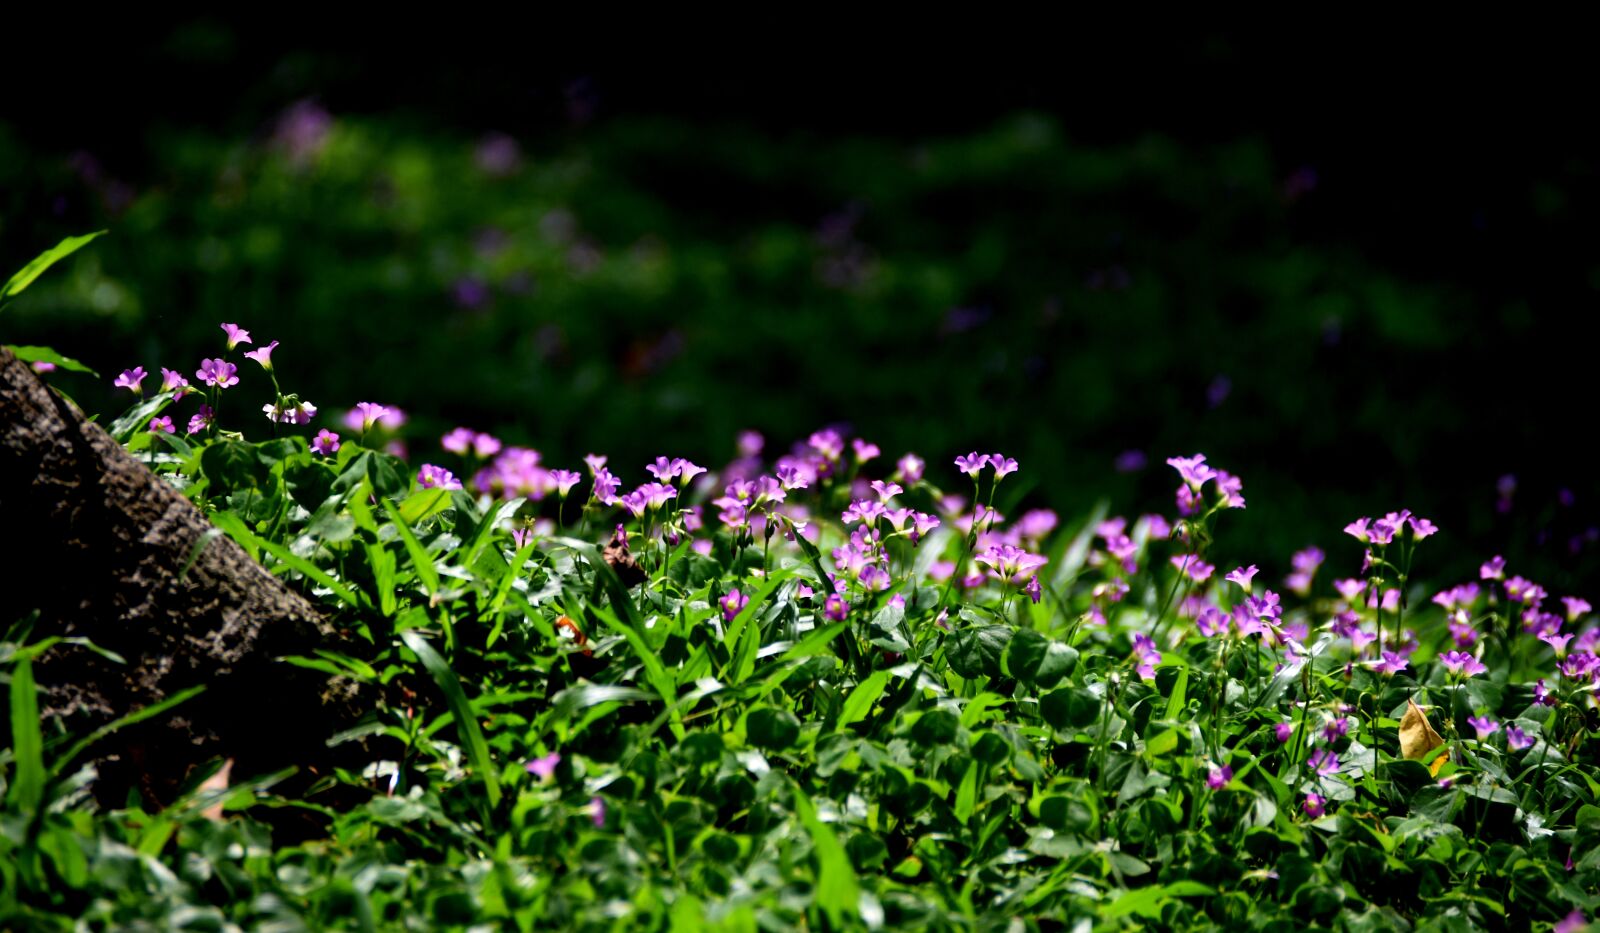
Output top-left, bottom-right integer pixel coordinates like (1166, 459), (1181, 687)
(9, 238), (1600, 930)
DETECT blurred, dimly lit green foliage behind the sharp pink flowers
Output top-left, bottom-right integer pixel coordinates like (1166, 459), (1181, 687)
(0, 109), (1594, 584)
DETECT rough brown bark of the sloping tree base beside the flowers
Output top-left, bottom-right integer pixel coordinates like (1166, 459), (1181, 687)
(0, 347), (363, 803)
